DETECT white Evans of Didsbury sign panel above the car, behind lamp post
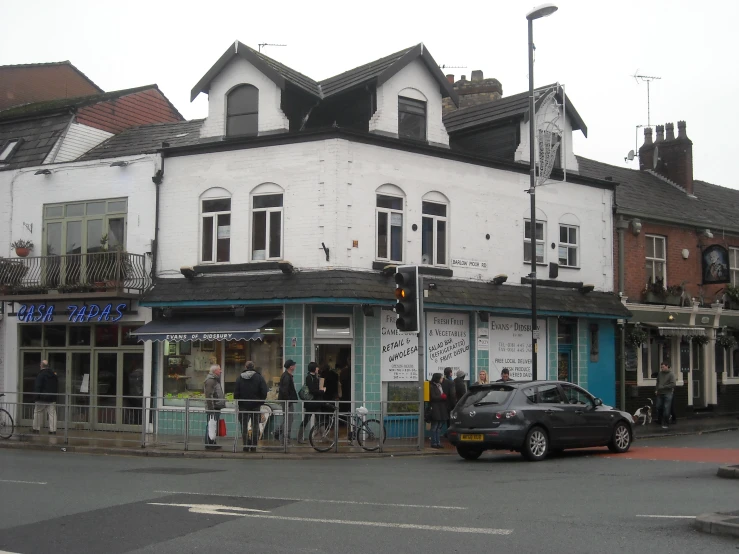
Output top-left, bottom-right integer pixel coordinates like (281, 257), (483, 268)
(489, 317), (547, 381)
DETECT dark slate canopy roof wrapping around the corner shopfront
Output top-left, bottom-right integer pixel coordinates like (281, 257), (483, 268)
(142, 270), (630, 317)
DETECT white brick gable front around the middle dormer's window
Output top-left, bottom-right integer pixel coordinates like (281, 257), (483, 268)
(370, 59), (449, 146)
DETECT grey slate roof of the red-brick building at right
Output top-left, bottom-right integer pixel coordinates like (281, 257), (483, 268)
(577, 156), (739, 232)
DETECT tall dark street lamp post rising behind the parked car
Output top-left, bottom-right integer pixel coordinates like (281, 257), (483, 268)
(526, 4), (557, 380)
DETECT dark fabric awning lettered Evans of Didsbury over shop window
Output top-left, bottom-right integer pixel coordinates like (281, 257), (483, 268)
(132, 315), (274, 342)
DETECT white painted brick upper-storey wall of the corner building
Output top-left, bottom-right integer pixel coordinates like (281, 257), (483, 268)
(160, 139), (613, 290)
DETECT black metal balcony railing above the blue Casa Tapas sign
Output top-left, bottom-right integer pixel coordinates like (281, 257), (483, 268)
(0, 250), (151, 296)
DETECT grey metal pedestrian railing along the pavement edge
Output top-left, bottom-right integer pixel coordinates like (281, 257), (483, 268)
(0, 393), (423, 453)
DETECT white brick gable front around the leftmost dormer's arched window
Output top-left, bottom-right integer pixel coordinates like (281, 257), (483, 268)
(200, 57), (290, 137)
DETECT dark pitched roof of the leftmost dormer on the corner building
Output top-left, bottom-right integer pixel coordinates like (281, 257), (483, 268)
(190, 40), (321, 100)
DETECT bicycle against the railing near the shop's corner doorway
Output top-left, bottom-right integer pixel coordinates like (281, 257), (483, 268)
(308, 406), (387, 452)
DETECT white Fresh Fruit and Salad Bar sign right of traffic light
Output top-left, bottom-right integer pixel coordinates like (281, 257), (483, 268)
(426, 312), (470, 379)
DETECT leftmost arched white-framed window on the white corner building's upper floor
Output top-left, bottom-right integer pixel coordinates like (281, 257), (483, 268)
(200, 188), (231, 263)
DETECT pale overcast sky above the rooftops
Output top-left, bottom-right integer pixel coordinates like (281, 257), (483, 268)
(0, 0), (739, 189)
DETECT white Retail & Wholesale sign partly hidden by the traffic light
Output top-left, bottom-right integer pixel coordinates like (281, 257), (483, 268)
(380, 310), (418, 381)
